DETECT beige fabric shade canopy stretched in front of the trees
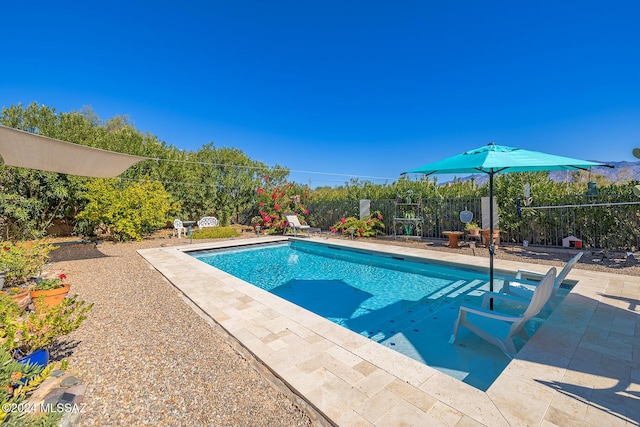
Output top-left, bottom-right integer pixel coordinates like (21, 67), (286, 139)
(0, 125), (148, 178)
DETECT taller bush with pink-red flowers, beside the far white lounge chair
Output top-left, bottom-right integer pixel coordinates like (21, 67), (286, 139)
(252, 176), (309, 234)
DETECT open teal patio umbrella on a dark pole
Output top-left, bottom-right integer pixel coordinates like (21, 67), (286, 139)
(403, 142), (613, 309)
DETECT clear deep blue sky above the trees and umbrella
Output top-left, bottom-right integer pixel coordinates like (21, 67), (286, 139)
(0, 0), (640, 186)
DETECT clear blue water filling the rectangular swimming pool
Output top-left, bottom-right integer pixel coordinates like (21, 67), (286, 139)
(191, 241), (560, 390)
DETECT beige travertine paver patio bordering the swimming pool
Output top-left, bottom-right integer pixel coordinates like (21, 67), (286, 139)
(139, 237), (640, 426)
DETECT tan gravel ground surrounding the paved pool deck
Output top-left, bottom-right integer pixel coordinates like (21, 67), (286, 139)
(43, 233), (640, 426)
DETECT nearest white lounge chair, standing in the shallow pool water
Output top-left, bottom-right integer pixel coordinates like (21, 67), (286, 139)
(449, 267), (556, 358)
